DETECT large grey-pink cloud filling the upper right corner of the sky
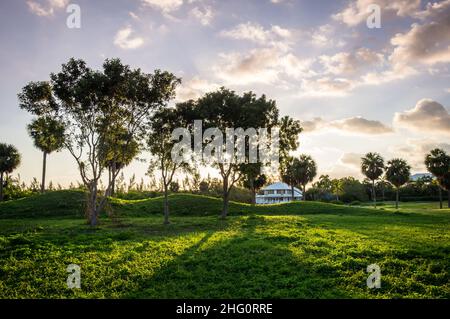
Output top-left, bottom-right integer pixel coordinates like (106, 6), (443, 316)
(391, 0), (450, 65)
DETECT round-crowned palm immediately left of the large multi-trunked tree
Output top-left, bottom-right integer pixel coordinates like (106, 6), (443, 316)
(28, 116), (65, 193)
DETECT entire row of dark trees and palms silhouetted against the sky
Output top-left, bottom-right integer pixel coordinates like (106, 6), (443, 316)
(0, 58), (450, 226)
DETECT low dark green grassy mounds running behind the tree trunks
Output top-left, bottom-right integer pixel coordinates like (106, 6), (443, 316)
(0, 191), (375, 219)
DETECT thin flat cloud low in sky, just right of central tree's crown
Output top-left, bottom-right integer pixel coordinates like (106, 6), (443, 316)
(301, 116), (393, 135)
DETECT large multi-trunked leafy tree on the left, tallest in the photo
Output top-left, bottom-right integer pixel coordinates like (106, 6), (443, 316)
(19, 59), (179, 226)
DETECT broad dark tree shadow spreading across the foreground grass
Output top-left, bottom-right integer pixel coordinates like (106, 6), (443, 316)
(122, 216), (356, 298)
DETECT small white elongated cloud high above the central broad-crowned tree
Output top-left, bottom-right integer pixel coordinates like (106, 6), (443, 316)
(220, 22), (291, 44)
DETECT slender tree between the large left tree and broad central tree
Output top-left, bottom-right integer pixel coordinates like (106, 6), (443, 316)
(147, 105), (192, 225)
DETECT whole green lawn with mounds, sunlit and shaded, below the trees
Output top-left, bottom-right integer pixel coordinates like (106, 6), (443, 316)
(0, 192), (450, 298)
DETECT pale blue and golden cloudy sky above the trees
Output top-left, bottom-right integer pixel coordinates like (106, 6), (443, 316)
(0, 0), (450, 185)
